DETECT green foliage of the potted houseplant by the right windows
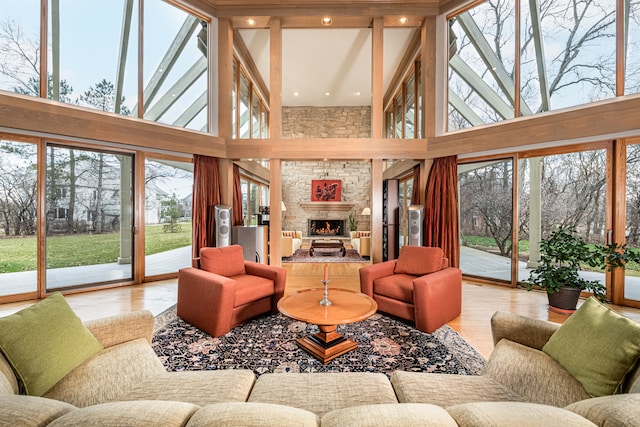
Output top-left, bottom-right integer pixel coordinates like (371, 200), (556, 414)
(525, 227), (640, 302)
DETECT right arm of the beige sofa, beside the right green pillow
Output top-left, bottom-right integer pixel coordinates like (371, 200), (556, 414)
(491, 311), (560, 350)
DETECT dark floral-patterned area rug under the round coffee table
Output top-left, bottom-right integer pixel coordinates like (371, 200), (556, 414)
(152, 306), (485, 375)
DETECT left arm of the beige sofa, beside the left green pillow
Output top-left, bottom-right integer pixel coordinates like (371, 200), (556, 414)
(84, 310), (154, 347)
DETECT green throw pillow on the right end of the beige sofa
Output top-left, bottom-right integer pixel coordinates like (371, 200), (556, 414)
(542, 297), (640, 397)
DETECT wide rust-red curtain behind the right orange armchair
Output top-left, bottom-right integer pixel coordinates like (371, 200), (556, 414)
(425, 156), (460, 267)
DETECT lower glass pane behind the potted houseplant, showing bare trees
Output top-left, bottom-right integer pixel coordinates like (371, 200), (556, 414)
(518, 149), (607, 283)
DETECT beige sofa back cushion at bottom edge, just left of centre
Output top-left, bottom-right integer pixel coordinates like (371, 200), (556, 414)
(187, 402), (320, 427)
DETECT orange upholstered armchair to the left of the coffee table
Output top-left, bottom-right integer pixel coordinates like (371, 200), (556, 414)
(177, 245), (287, 337)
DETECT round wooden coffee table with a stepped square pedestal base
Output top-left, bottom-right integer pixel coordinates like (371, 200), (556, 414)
(278, 288), (378, 363)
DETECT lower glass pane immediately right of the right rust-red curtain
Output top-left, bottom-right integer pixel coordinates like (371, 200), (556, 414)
(458, 159), (513, 281)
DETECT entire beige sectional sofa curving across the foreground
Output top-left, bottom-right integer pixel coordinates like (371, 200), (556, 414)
(0, 311), (640, 427)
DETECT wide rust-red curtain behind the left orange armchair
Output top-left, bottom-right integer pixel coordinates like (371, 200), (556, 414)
(192, 154), (221, 257)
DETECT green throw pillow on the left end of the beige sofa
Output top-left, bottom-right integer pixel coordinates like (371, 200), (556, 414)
(0, 293), (102, 396)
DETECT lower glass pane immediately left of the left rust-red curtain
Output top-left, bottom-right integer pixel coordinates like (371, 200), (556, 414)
(144, 159), (193, 277)
